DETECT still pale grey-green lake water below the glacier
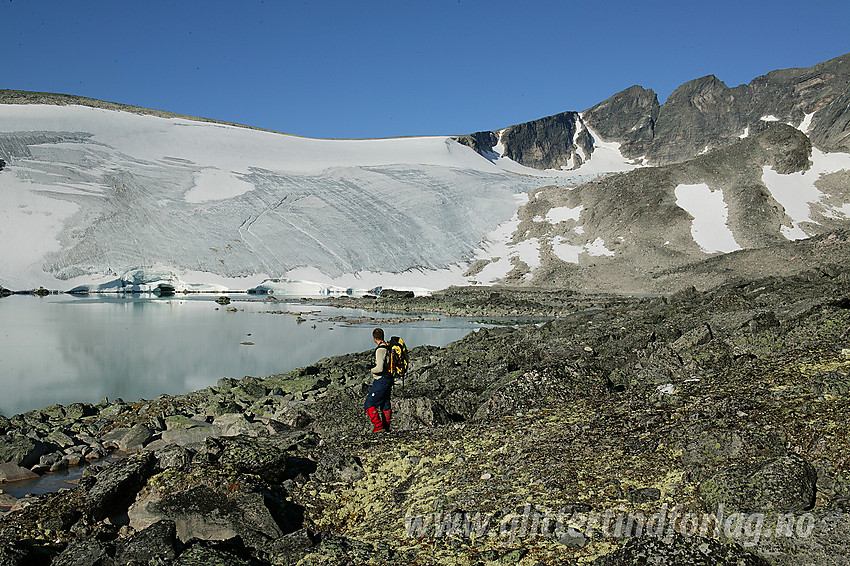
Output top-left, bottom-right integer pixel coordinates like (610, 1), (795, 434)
(0, 295), (480, 416)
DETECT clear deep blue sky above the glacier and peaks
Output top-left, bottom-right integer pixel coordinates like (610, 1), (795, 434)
(0, 0), (850, 138)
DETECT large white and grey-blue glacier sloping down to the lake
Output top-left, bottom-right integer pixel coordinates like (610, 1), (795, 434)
(0, 105), (563, 292)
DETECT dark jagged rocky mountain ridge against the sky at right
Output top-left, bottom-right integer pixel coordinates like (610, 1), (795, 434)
(458, 54), (850, 169)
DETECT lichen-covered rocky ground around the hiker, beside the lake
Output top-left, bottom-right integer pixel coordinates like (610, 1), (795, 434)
(0, 270), (850, 566)
